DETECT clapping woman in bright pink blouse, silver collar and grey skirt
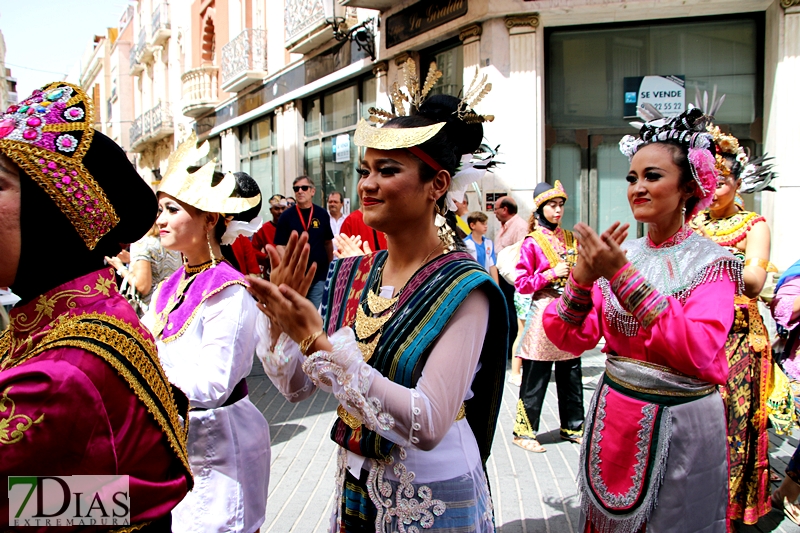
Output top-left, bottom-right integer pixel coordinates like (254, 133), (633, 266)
(544, 108), (741, 533)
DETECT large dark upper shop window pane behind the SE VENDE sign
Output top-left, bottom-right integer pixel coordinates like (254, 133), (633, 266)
(547, 19), (760, 128)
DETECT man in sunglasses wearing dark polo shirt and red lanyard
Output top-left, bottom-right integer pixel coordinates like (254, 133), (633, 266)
(275, 176), (333, 307)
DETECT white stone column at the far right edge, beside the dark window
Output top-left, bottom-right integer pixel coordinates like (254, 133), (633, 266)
(761, 0), (800, 270)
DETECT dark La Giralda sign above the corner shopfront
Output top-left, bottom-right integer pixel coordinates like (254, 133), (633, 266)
(386, 0), (467, 48)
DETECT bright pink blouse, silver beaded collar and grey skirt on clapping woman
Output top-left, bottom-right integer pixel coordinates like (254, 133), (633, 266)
(544, 227), (742, 532)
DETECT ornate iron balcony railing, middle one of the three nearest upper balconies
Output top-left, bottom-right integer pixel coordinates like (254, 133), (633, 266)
(222, 28), (267, 92)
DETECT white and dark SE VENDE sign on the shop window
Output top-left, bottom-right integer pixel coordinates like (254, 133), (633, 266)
(623, 76), (686, 119)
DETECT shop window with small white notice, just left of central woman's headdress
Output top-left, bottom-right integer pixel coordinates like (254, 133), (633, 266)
(304, 76), (377, 211)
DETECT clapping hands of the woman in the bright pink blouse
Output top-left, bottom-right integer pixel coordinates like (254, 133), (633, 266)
(572, 222), (630, 287)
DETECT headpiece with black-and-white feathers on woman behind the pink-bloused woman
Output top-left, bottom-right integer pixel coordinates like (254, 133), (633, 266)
(690, 85), (778, 194)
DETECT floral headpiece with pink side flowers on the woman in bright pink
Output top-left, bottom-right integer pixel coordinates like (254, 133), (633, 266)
(619, 104), (718, 210)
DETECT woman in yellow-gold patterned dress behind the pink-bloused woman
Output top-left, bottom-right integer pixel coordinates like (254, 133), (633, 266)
(691, 105), (774, 524)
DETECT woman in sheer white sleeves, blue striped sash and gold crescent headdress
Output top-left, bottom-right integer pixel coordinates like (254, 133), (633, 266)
(247, 61), (508, 532)
